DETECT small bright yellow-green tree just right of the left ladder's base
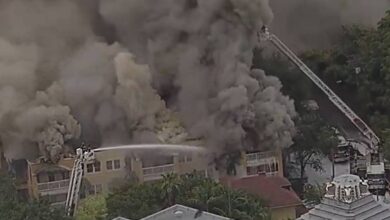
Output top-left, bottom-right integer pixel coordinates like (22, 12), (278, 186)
(75, 195), (107, 220)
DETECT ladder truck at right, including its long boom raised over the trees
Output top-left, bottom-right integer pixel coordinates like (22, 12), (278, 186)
(257, 26), (387, 194)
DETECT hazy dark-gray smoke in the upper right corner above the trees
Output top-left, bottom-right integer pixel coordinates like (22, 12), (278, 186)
(270, 0), (390, 51)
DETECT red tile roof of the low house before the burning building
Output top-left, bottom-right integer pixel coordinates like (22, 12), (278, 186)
(221, 175), (302, 208)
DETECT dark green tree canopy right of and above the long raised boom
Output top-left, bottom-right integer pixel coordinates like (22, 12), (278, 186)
(303, 11), (390, 133)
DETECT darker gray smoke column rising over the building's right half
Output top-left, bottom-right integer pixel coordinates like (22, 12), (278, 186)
(100, 0), (295, 152)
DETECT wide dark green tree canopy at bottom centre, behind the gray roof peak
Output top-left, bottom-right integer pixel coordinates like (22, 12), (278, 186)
(107, 173), (269, 220)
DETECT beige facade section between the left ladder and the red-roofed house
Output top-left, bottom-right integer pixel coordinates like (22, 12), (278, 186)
(84, 142), (215, 194)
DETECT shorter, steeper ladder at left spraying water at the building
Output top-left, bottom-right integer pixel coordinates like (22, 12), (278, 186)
(65, 146), (95, 216)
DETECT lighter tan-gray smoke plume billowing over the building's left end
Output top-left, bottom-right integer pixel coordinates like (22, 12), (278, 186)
(0, 0), (163, 161)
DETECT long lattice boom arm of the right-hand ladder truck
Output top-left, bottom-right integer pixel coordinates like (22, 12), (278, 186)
(259, 28), (380, 151)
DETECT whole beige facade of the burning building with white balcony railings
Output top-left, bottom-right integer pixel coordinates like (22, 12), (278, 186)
(19, 145), (283, 205)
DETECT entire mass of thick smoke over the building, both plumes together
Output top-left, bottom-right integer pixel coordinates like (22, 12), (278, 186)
(0, 0), (295, 161)
